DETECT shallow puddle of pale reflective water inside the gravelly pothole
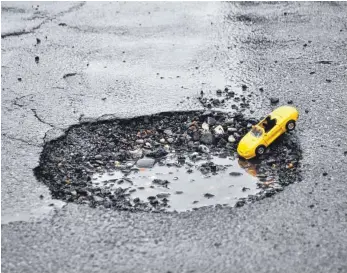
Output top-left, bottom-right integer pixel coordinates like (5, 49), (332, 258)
(92, 154), (260, 211)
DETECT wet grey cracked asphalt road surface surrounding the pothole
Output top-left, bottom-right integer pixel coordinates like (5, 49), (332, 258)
(1, 2), (347, 272)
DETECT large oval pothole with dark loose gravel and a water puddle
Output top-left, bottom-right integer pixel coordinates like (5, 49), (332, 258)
(35, 111), (301, 212)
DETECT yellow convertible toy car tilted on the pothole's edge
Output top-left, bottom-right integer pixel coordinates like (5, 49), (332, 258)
(237, 106), (299, 159)
